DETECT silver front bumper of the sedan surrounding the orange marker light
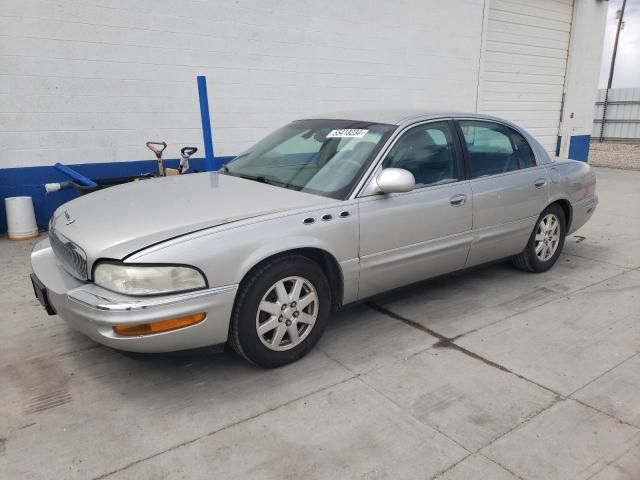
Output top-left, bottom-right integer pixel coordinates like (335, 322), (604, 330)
(31, 239), (238, 352)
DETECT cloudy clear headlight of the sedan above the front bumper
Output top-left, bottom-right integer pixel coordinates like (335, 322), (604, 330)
(93, 262), (207, 295)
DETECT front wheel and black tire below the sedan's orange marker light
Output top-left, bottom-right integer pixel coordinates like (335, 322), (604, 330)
(229, 255), (331, 368)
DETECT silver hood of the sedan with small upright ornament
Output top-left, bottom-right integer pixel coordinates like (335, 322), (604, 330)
(52, 172), (336, 263)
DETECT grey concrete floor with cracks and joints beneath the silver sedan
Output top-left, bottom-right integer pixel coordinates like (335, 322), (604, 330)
(0, 169), (640, 480)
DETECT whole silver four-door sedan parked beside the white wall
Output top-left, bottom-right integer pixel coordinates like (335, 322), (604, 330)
(31, 112), (598, 367)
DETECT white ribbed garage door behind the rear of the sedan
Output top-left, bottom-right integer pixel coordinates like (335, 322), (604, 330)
(478, 0), (573, 152)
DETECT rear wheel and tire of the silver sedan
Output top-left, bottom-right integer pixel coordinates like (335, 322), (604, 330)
(513, 203), (567, 273)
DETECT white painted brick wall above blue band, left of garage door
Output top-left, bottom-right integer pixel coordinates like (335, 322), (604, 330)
(0, 0), (484, 168)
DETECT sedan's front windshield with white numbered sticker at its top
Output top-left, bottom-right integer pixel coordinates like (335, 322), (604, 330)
(222, 120), (395, 199)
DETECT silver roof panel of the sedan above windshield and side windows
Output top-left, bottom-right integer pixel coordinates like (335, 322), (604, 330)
(306, 108), (511, 125)
